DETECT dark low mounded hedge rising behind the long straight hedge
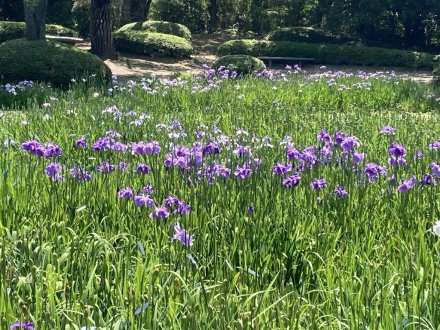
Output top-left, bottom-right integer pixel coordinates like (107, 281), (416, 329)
(266, 26), (355, 44)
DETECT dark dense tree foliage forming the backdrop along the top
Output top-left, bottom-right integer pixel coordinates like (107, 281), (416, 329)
(0, 0), (440, 53)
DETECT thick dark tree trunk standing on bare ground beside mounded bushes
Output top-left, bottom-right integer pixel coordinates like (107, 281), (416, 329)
(91, 0), (116, 59)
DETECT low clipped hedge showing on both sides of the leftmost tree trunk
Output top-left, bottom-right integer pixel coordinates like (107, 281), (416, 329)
(0, 21), (78, 43)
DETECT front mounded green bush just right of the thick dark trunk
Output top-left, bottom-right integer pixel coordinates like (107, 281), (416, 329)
(113, 30), (193, 58)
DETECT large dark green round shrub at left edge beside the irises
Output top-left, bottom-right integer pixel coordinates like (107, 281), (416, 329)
(0, 39), (111, 87)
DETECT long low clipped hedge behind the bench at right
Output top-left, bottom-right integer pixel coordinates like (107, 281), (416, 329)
(218, 39), (434, 70)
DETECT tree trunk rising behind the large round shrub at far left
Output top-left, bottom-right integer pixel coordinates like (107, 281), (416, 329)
(23, 0), (47, 40)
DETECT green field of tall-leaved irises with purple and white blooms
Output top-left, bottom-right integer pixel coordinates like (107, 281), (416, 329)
(0, 71), (440, 329)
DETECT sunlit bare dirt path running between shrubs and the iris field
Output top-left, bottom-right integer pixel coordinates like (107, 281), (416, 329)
(79, 34), (432, 83)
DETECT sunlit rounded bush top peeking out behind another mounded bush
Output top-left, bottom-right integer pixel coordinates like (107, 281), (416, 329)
(118, 21), (191, 40)
